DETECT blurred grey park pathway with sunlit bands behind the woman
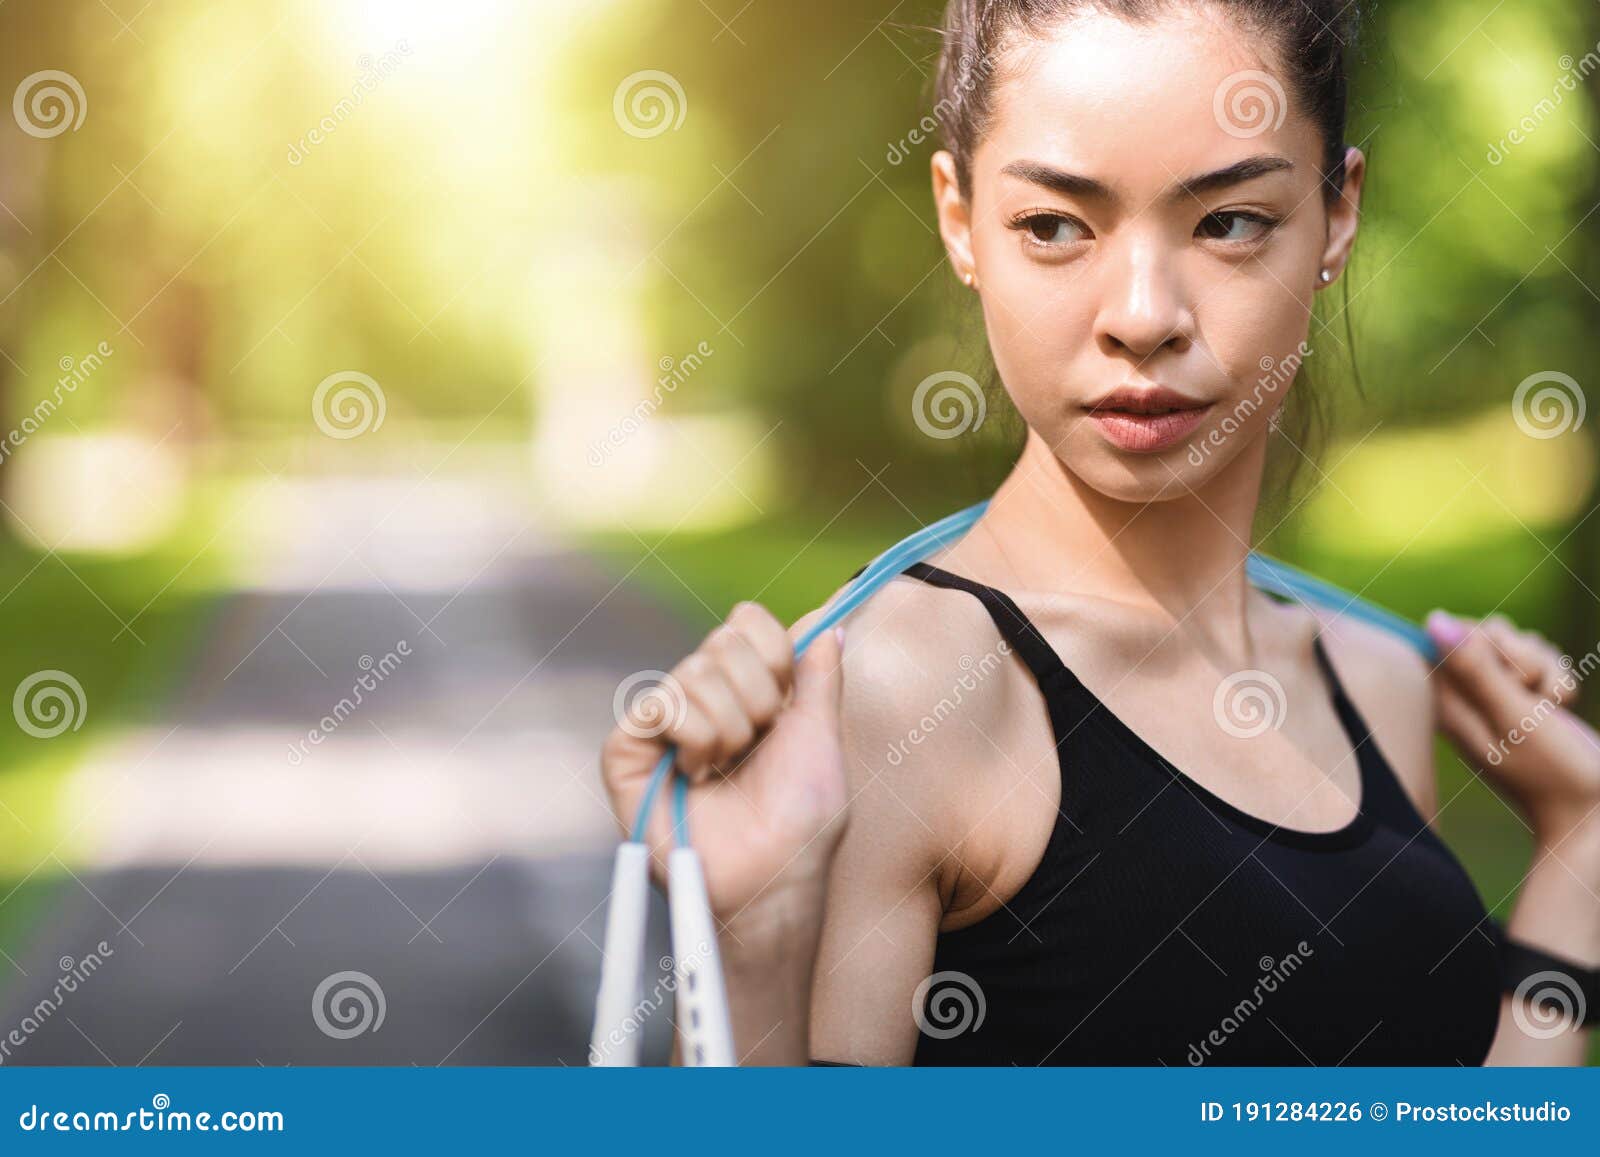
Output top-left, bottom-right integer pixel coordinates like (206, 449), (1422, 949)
(0, 482), (694, 1064)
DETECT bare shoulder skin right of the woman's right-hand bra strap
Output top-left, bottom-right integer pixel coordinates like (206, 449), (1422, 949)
(1314, 610), (1438, 823)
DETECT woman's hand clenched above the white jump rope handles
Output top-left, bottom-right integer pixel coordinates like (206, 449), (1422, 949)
(600, 603), (846, 923)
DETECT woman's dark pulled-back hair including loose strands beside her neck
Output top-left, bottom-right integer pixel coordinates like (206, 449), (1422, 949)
(934, 0), (1362, 510)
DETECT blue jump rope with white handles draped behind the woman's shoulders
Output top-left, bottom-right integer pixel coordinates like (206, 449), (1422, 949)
(589, 502), (1438, 1066)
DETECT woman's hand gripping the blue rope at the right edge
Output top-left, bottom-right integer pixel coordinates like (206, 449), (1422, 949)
(1427, 611), (1600, 843)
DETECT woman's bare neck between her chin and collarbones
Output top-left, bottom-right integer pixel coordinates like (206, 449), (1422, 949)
(971, 430), (1266, 656)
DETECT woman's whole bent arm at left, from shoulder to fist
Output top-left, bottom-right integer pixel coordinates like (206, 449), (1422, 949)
(602, 583), (972, 1064)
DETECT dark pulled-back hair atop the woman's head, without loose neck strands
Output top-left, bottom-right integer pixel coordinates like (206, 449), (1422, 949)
(934, 0), (1360, 200)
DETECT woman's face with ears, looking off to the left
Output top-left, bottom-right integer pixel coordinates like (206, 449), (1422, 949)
(934, 6), (1363, 502)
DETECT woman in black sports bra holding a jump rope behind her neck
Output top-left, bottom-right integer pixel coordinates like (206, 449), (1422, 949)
(603, 0), (1600, 1064)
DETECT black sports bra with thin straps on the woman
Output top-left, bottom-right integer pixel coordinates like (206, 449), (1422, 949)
(904, 563), (1501, 1066)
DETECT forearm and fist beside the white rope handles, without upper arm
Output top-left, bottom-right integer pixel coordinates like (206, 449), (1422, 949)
(600, 603), (848, 1063)
